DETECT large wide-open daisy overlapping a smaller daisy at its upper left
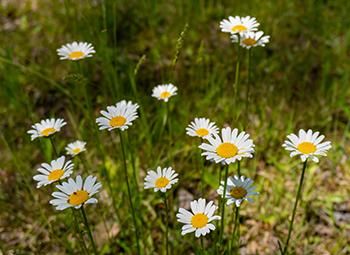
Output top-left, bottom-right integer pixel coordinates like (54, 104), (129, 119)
(199, 127), (255, 164)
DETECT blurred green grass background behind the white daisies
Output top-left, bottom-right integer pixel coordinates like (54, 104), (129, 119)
(0, 0), (350, 254)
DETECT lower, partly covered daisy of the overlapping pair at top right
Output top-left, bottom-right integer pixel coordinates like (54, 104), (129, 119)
(231, 31), (270, 49)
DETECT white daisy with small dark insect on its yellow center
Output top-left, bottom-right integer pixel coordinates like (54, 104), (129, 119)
(50, 175), (102, 210)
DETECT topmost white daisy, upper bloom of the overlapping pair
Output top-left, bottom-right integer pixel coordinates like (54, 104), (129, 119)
(220, 16), (260, 35)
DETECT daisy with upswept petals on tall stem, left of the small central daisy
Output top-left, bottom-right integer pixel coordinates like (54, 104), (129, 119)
(96, 100), (139, 131)
